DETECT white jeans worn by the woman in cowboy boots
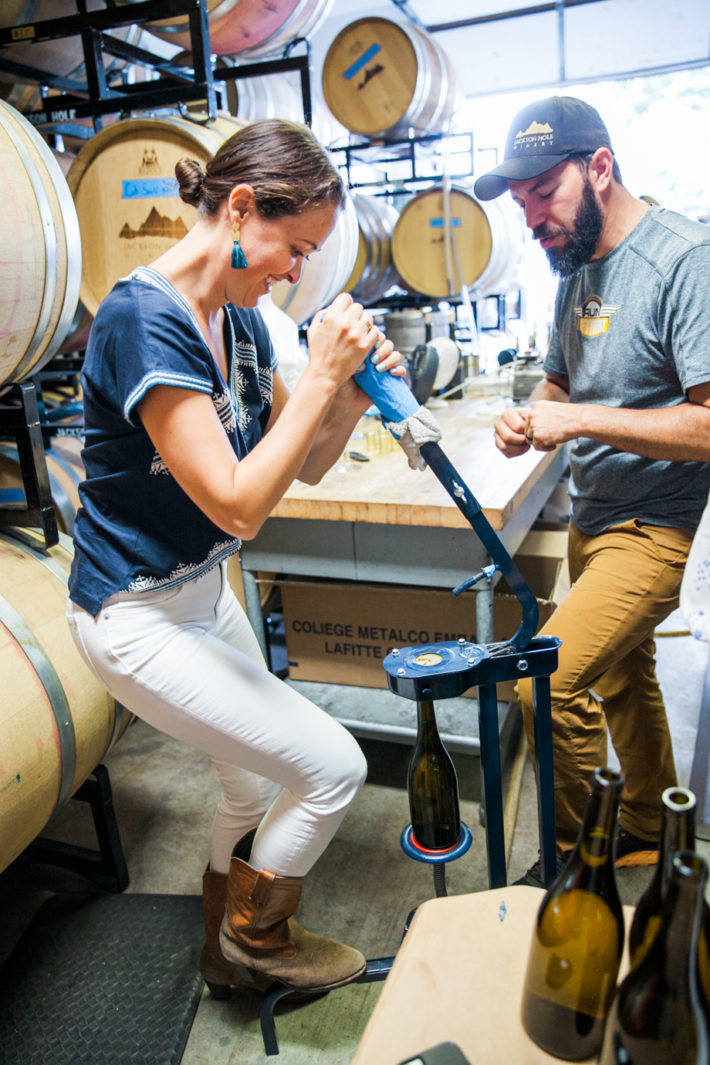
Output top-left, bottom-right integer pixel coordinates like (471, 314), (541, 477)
(67, 564), (367, 876)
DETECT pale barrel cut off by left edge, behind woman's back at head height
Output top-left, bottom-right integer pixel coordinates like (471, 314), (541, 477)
(0, 100), (81, 391)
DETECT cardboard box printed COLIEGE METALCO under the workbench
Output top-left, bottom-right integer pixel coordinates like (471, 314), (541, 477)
(281, 531), (566, 701)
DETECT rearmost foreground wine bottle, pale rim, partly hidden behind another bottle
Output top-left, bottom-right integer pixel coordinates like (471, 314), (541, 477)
(629, 787), (710, 1002)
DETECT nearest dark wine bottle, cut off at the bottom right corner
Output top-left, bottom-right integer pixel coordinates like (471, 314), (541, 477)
(599, 851), (710, 1065)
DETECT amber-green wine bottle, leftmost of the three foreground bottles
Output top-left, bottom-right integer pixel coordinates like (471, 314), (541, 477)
(522, 769), (624, 1061)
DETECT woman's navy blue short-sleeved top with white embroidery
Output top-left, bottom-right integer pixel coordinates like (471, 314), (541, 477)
(69, 267), (277, 616)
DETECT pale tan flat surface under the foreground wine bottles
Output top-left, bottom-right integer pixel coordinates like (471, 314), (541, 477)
(352, 887), (633, 1065)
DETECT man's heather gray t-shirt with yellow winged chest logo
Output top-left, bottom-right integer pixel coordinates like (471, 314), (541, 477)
(545, 208), (710, 536)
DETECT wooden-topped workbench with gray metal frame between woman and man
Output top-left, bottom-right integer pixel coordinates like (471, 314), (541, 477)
(241, 398), (566, 648)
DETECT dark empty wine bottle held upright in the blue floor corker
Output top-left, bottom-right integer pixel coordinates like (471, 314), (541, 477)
(407, 700), (461, 851)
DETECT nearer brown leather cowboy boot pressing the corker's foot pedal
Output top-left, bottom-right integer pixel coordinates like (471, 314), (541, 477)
(219, 857), (365, 990)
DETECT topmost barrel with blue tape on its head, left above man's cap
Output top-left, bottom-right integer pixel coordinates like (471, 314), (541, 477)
(323, 18), (459, 138)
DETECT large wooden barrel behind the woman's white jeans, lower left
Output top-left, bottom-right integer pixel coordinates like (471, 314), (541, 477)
(0, 533), (131, 870)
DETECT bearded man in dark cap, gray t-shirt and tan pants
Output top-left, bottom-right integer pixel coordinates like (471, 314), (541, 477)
(475, 97), (710, 884)
